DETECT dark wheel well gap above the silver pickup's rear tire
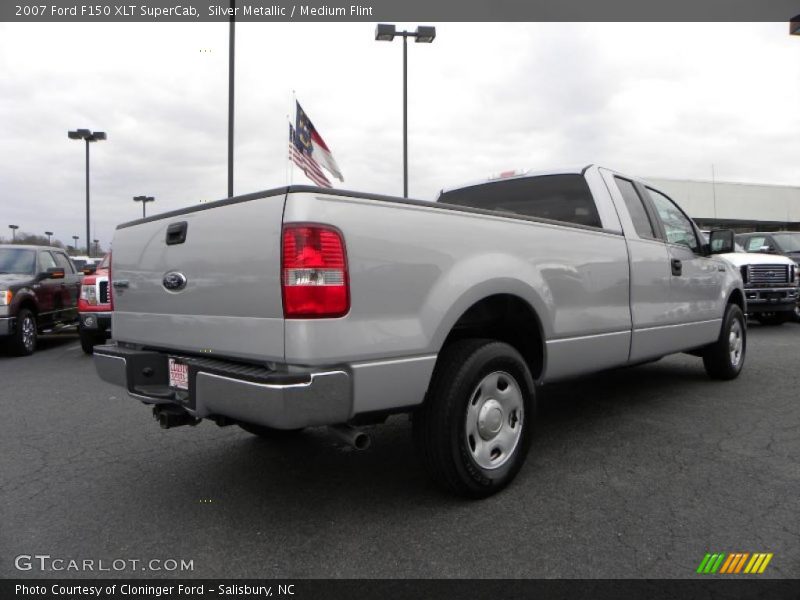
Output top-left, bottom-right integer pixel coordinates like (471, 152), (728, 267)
(444, 294), (544, 380)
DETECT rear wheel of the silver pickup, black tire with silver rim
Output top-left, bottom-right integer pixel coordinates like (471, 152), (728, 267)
(413, 339), (536, 498)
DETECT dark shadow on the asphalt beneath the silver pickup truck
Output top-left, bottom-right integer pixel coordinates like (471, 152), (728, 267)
(172, 356), (714, 506)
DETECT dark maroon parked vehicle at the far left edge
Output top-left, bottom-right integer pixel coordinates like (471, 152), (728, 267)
(0, 244), (80, 356)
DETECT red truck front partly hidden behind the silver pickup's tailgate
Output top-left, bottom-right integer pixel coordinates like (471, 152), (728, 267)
(78, 255), (114, 354)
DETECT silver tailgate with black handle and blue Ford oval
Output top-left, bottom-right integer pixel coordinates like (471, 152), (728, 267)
(111, 189), (286, 363)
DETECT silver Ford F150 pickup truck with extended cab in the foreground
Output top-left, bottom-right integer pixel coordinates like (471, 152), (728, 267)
(94, 166), (746, 497)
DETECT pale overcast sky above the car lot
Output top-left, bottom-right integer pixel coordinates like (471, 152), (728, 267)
(0, 23), (800, 245)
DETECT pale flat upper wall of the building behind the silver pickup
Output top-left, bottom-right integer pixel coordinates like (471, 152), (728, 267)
(646, 177), (800, 232)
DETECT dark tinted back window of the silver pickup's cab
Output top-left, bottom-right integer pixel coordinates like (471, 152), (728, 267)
(437, 173), (602, 228)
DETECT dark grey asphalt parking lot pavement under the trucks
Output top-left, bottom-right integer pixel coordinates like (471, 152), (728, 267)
(0, 324), (800, 578)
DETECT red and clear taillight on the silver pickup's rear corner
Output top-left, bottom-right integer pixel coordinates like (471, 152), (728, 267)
(281, 225), (350, 319)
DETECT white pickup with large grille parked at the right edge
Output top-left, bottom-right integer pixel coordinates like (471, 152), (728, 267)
(703, 236), (800, 325)
